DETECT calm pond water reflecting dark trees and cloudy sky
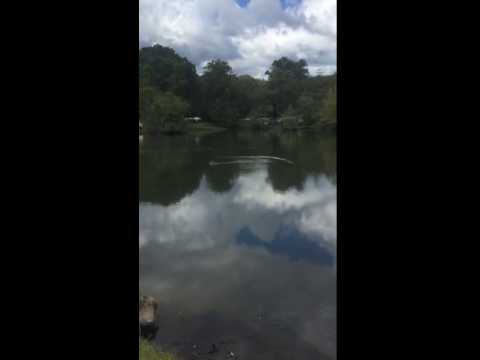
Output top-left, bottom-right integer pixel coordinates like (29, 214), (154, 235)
(139, 132), (337, 360)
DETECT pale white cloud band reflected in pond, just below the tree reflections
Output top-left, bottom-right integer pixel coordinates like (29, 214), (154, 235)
(139, 170), (337, 252)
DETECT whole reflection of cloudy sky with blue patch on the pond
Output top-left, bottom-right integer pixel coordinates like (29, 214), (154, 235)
(139, 168), (336, 359)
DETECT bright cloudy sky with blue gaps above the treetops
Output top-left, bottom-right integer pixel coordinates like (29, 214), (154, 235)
(139, 0), (337, 78)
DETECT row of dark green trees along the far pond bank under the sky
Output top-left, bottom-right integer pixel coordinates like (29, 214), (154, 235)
(139, 45), (336, 128)
